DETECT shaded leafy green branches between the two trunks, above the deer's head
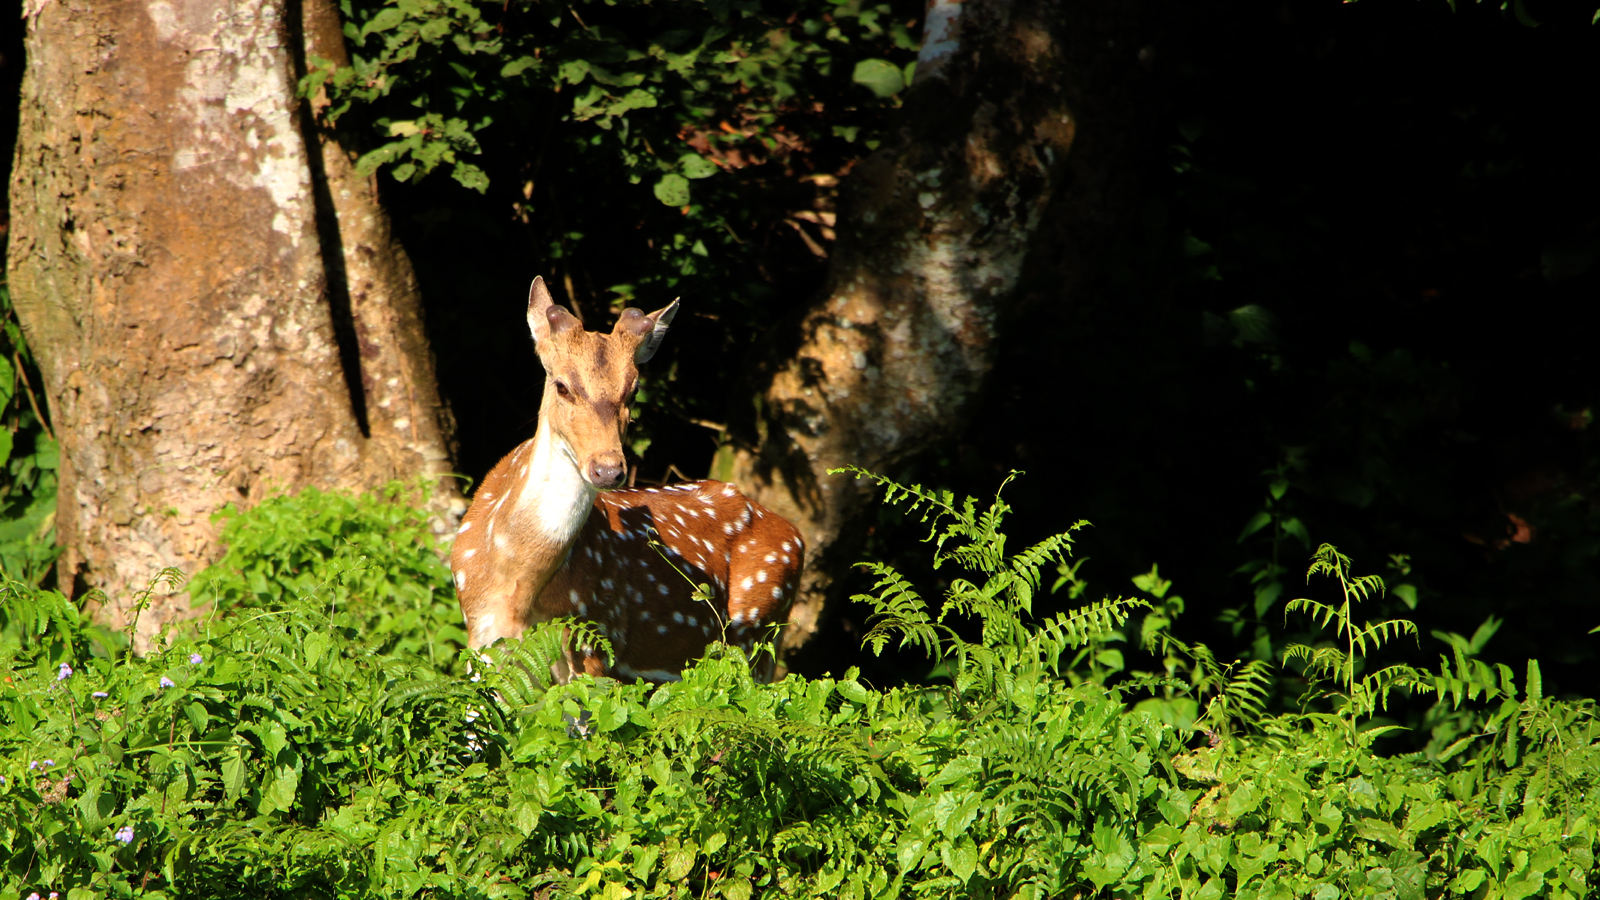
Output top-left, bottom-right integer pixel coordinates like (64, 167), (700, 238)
(313, 0), (917, 323)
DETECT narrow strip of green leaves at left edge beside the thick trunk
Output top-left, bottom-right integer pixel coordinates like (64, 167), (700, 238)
(0, 283), (61, 585)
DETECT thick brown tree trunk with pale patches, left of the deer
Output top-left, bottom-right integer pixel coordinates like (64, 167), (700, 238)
(8, 0), (459, 636)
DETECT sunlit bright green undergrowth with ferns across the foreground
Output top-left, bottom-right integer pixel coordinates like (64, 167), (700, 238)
(0, 482), (1600, 900)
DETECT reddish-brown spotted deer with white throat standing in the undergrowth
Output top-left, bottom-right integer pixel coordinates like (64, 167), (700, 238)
(450, 279), (803, 681)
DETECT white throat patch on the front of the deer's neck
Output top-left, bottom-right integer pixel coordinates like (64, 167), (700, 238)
(514, 421), (600, 573)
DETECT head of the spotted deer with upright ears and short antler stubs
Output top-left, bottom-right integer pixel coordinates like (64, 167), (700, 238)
(528, 279), (678, 490)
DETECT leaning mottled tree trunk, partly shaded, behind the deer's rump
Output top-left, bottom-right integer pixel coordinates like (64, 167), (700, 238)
(712, 0), (1138, 650)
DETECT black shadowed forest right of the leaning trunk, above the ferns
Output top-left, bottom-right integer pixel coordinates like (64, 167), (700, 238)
(835, 3), (1600, 693)
